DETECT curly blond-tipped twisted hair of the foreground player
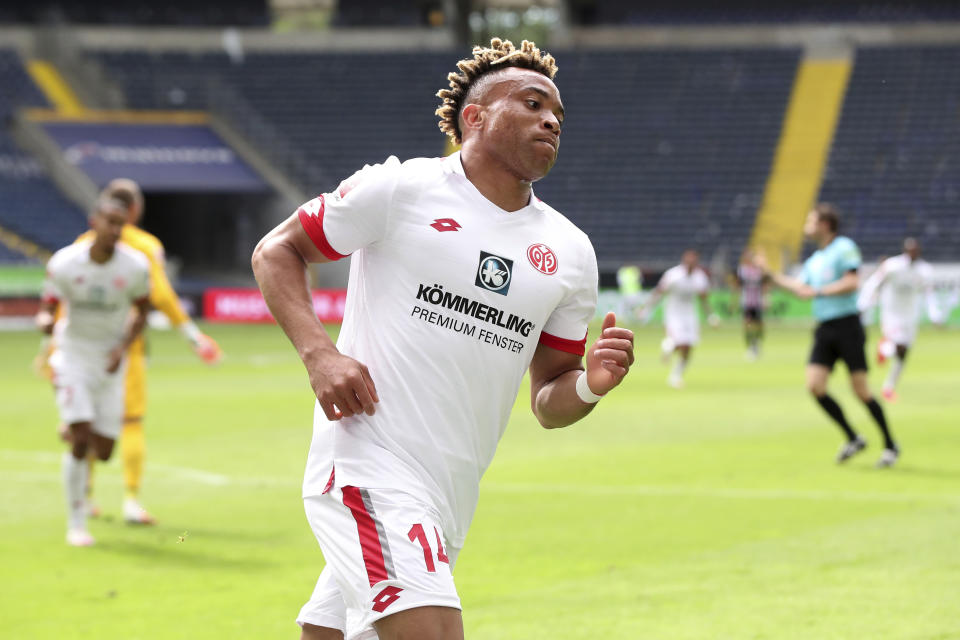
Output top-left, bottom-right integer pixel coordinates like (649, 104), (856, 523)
(435, 38), (557, 144)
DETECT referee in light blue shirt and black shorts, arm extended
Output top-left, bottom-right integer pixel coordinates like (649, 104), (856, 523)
(758, 203), (900, 467)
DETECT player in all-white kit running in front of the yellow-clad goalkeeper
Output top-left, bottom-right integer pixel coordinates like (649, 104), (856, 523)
(36, 198), (150, 546)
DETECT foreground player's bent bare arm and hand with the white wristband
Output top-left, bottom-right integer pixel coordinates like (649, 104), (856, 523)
(530, 312), (633, 429)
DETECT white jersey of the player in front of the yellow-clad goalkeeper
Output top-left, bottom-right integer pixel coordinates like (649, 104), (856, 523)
(43, 240), (150, 362)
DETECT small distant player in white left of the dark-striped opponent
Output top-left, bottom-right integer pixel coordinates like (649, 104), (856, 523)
(639, 249), (720, 389)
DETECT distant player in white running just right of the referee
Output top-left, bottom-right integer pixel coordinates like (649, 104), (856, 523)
(857, 238), (943, 400)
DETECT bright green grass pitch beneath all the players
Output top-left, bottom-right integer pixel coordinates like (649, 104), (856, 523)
(0, 326), (960, 640)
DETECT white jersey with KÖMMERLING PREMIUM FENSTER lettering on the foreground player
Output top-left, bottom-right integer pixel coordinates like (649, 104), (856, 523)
(299, 153), (597, 547)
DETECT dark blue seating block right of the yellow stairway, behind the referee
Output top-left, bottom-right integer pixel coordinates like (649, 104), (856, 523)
(821, 47), (960, 261)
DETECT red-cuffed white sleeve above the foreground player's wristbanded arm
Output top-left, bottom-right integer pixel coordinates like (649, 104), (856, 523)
(540, 240), (598, 356)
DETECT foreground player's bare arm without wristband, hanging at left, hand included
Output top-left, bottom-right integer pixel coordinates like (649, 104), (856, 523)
(252, 213), (379, 420)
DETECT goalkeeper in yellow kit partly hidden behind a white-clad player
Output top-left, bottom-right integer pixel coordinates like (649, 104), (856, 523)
(60, 178), (221, 524)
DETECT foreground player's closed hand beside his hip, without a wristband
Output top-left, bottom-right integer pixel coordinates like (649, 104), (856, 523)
(304, 349), (380, 420)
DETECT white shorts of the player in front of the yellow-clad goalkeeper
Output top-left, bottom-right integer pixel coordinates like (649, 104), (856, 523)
(50, 350), (126, 440)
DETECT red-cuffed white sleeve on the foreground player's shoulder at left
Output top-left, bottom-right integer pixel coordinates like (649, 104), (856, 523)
(297, 156), (400, 260)
